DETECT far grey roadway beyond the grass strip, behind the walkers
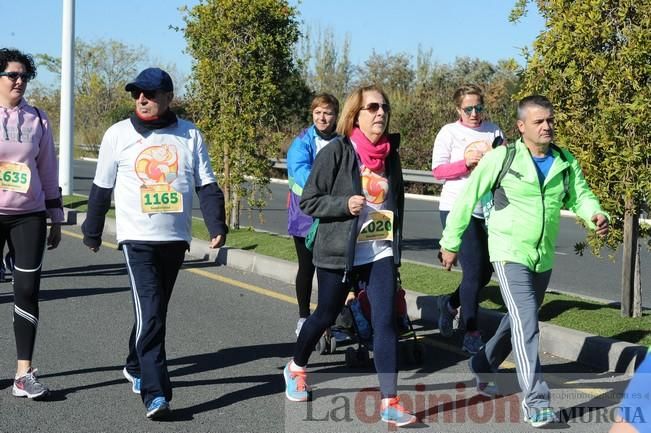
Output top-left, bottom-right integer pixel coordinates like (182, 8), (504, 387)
(74, 157), (651, 308)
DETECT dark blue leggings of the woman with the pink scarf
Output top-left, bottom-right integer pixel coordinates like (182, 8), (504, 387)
(294, 257), (398, 398)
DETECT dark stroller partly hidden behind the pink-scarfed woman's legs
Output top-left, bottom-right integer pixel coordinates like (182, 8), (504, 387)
(333, 278), (424, 367)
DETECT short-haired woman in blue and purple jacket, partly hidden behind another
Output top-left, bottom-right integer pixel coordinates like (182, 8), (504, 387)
(287, 93), (339, 336)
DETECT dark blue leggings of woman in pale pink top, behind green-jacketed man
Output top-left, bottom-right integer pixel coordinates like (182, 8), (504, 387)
(440, 211), (493, 332)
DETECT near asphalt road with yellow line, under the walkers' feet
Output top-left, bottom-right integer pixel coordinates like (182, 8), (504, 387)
(0, 226), (626, 433)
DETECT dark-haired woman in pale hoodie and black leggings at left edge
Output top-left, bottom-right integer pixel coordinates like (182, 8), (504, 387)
(0, 48), (63, 398)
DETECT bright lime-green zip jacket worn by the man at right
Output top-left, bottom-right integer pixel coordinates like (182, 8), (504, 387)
(440, 139), (608, 272)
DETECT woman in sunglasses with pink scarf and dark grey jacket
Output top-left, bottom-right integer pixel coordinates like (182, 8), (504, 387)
(284, 86), (416, 426)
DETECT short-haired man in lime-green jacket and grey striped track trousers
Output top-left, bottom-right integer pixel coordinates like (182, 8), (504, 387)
(440, 95), (608, 427)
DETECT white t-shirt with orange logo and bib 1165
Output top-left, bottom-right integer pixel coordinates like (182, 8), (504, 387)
(93, 119), (216, 243)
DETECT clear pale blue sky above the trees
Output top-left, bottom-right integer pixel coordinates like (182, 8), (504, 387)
(0, 0), (544, 88)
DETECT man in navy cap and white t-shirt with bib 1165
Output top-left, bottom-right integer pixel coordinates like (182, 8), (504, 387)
(82, 68), (228, 419)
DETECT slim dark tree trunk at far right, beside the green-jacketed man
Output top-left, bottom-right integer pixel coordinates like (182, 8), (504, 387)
(621, 197), (640, 317)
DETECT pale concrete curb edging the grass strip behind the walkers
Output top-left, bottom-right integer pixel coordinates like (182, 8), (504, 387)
(65, 209), (648, 373)
